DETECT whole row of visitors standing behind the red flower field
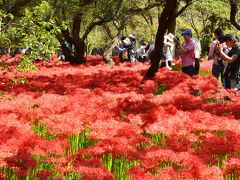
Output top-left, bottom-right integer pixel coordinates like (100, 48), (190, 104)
(117, 28), (240, 90)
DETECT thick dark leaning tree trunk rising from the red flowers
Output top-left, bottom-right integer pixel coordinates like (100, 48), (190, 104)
(145, 0), (177, 78)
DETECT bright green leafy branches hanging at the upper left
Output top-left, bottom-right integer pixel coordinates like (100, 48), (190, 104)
(0, 1), (59, 59)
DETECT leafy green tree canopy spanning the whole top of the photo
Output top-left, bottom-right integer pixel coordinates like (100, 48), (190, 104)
(0, 0), (240, 67)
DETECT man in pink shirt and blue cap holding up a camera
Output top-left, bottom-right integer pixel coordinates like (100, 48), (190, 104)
(175, 29), (195, 76)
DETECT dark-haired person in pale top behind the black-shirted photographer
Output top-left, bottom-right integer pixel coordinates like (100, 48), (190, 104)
(208, 28), (226, 84)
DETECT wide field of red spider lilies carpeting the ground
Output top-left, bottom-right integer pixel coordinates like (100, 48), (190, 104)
(0, 55), (240, 180)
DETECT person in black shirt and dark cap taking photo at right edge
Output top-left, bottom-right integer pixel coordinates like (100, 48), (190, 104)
(216, 34), (240, 88)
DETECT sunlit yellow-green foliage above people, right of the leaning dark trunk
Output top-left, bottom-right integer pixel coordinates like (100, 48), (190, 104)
(177, 0), (237, 56)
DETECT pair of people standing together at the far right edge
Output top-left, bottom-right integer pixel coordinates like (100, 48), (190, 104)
(208, 28), (240, 90)
